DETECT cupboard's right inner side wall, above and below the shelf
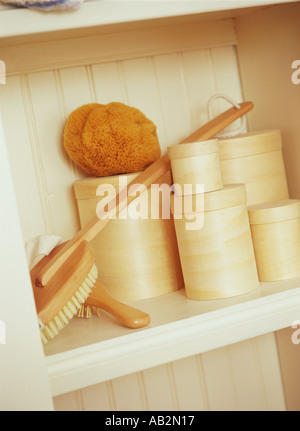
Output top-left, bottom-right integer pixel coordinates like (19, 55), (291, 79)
(236, 2), (300, 410)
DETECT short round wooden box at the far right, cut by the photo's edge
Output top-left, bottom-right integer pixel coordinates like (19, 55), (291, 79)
(248, 199), (300, 281)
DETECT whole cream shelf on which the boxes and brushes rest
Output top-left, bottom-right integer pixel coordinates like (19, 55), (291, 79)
(45, 278), (300, 396)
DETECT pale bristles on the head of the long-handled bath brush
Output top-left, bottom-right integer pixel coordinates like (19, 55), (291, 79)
(40, 265), (98, 344)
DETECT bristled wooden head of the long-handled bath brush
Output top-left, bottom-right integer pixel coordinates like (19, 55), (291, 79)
(30, 241), (98, 343)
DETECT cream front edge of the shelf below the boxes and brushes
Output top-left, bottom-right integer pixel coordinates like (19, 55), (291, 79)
(46, 287), (300, 396)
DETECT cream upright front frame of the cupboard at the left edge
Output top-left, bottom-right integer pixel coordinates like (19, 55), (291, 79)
(0, 117), (53, 411)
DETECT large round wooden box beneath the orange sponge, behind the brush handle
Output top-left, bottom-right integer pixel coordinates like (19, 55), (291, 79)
(74, 173), (183, 301)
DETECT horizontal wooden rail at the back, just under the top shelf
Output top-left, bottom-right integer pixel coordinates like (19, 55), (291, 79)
(0, 15), (236, 74)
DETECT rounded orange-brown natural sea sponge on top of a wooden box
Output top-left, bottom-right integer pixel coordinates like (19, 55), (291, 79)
(64, 102), (161, 177)
